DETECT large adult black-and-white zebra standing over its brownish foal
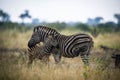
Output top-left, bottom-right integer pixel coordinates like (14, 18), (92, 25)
(28, 26), (93, 64)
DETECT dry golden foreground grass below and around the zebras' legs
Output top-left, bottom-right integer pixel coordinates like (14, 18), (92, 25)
(0, 53), (120, 80)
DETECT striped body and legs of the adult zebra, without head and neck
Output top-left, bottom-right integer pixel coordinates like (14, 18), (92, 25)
(44, 33), (93, 65)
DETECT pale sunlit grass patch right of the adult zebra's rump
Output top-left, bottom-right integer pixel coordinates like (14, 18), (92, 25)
(94, 33), (120, 49)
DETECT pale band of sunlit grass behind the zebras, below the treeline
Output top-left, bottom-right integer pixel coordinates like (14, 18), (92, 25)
(0, 29), (120, 49)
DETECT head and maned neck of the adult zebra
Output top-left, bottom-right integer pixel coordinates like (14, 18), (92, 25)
(28, 26), (59, 48)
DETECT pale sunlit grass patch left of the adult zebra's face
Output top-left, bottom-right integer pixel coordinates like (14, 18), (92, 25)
(0, 29), (32, 48)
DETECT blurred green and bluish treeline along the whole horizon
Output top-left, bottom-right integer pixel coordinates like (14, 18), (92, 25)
(0, 10), (120, 33)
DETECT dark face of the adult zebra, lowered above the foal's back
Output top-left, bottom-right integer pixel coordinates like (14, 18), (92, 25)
(28, 27), (41, 48)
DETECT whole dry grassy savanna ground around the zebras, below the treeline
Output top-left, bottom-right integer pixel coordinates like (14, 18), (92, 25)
(0, 23), (120, 80)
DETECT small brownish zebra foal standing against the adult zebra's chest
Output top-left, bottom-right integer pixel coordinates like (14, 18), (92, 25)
(28, 36), (59, 64)
